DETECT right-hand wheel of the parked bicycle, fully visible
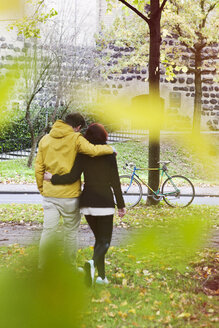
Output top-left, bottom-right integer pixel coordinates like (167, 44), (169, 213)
(162, 175), (195, 207)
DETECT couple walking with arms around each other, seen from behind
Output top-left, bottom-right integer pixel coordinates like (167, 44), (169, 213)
(35, 113), (126, 285)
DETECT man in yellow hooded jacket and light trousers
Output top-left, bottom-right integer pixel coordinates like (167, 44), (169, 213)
(35, 113), (113, 268)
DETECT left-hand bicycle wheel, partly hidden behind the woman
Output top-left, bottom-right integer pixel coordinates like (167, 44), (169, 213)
(119, 175), (142, 208)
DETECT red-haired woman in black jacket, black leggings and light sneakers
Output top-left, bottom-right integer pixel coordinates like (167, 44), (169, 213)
(44, 123), (126, 285)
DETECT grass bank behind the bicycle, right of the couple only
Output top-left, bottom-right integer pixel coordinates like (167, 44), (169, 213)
(115, 137), (219, 185)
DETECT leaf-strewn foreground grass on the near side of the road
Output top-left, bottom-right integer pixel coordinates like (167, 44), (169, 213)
(0, 204), (219, 328)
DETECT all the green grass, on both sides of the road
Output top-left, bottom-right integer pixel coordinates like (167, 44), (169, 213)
(0, 140), (219, 328)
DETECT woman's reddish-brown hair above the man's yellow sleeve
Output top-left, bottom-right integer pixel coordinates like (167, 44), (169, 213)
(84, 123), (108, 145)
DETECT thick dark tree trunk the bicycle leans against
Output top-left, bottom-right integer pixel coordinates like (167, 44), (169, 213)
(147, 0), (161, 205)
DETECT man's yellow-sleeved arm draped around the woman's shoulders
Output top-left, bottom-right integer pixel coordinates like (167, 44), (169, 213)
(76, 135), (113, 157)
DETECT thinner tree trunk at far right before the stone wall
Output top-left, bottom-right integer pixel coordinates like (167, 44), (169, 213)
(193, 51), (202, 133)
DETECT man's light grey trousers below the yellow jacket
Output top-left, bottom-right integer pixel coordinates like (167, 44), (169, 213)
(39, 197), (81, 268)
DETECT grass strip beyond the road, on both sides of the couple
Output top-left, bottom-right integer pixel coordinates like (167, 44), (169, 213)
(0, 137), (219, 185)
